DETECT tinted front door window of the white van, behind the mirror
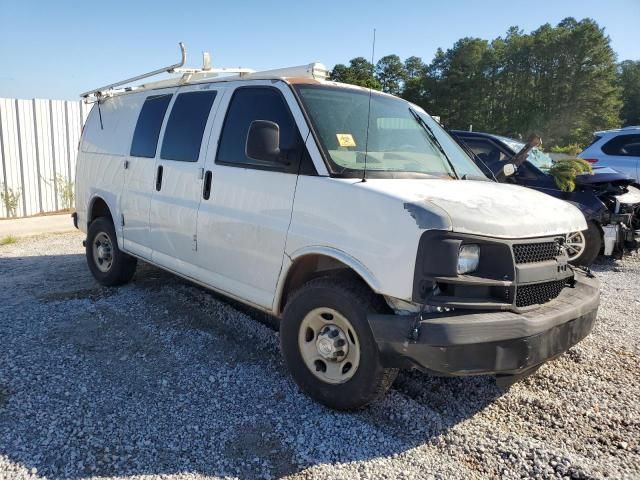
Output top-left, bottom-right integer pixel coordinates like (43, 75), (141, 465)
(216, 87), (304, 173)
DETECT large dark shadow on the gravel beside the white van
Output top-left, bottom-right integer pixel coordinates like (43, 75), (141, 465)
(0, 255), (501, 479)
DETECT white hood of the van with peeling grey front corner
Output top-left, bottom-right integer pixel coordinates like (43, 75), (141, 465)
(359, 179), (587, 238)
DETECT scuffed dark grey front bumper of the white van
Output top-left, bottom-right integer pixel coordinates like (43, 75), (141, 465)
(368, 271), (600, 375)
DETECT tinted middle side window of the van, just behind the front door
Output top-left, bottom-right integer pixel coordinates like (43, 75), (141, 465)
(160, 90), (217, 162)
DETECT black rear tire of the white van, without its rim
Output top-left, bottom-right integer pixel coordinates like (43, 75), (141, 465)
(86, 217), (138, 287)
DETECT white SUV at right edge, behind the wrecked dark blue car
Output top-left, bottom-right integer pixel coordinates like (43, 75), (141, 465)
(578, 126), (640, 182)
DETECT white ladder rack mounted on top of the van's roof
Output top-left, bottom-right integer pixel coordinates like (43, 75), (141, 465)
(80, 42), (329, 103)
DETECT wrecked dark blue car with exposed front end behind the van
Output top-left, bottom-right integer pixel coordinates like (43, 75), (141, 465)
(449, 130), (640, 266)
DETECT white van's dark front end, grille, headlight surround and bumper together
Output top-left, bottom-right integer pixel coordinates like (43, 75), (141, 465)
(368, 231), (600, 384)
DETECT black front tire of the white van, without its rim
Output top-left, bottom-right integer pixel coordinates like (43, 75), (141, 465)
(280, 276), (398, 410)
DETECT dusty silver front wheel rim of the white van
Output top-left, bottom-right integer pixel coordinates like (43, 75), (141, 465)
(298, 307), (360, 384)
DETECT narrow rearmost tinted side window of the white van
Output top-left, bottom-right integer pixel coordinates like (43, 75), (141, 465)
(130, 95), (171, 158)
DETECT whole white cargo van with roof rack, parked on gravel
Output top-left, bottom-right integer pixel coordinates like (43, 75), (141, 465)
(75, 47), (599, 409)
